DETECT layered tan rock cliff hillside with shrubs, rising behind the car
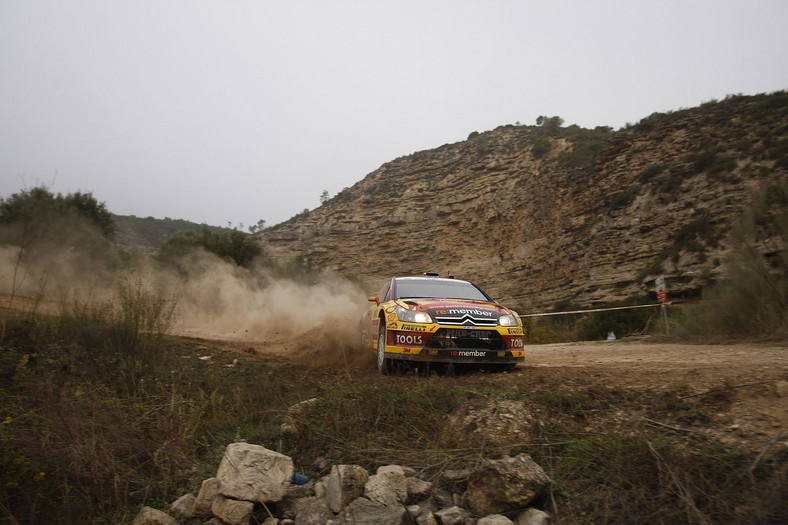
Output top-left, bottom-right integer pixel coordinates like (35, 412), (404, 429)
(258, 92), (788, 312)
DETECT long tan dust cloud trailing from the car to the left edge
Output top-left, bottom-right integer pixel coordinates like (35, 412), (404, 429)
(0, 237), (374, 368)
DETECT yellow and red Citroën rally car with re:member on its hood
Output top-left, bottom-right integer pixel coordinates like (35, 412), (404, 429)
(361, 273), (525, 374)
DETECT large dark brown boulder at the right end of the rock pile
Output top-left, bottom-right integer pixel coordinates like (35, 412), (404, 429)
(466, 454), (550, 515)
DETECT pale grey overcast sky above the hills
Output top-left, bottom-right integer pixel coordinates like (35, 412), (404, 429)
(0, 0), (788, 230)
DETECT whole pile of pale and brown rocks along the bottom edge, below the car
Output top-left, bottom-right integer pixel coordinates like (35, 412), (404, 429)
(134, 443), (550, 525)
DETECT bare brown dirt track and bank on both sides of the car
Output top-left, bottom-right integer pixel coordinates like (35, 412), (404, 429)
(180, 333), (788, 450)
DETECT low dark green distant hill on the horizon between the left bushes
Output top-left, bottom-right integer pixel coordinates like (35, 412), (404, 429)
(112, 214), (230, 253)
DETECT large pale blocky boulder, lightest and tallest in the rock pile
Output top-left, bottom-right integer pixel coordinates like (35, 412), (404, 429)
(216, 443), (293, 503)
